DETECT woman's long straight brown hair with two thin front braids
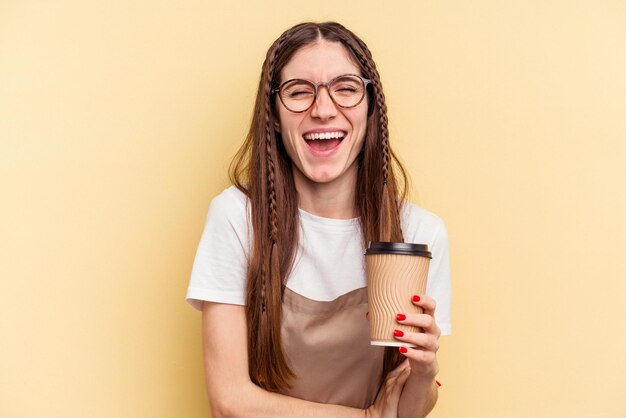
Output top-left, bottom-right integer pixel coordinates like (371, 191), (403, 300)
(230, 22), (407, 391)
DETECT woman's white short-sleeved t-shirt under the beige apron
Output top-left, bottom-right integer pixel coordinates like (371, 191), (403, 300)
(187, 186), (451, 335)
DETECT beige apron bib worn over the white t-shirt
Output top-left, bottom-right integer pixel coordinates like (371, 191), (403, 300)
(281, 288), (384, 408)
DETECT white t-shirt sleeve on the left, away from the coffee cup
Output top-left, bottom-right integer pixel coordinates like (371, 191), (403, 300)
(187, 187), (250, 310)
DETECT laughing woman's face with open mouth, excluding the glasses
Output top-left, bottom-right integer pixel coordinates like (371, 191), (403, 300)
(276, 40), (367, 186)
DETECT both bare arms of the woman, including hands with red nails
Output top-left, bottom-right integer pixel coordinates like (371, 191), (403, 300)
(202, 297), (439, 418)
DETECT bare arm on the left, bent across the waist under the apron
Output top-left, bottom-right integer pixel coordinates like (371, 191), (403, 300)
(202, 302), (409, 418)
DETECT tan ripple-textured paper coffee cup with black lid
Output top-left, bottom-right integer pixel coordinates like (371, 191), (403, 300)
(365, 242), (432, 347)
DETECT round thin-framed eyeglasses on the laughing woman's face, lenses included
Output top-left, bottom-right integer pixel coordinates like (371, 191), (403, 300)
(272, 74), (372, 113)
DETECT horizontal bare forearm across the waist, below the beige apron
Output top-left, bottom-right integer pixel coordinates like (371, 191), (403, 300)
(211, 382), (366, 418)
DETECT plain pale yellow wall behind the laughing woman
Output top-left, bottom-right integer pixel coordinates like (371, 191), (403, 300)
(0, 0), (626, 418)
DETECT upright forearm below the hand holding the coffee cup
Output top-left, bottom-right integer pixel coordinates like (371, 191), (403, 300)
(398, 373), (439, 418)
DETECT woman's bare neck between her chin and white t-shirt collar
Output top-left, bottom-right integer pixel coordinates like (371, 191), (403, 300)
(294, 170), (357, 219)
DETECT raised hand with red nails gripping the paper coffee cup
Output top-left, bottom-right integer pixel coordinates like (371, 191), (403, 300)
(394, 295), (441, 379)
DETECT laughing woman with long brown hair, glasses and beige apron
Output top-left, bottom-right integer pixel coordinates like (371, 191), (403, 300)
(187, 22), (450, 417)
